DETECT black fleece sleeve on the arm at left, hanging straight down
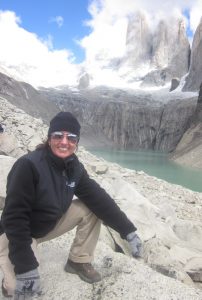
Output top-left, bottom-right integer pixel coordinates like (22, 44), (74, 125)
(2, 157), (38, 274)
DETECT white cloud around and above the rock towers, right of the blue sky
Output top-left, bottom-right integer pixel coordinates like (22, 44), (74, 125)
(80, 0), (202, 86)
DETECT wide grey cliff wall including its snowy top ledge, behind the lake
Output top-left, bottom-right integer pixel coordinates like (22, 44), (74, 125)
(41, 87), (197, 151)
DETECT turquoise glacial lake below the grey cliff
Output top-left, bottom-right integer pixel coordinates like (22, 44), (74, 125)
(88, 148), (202, 192)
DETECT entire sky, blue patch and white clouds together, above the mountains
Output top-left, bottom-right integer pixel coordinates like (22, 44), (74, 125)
(0, 0), (202, 86)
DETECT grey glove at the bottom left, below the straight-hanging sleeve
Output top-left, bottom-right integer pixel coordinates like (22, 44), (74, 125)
(14, 269), (42, 300)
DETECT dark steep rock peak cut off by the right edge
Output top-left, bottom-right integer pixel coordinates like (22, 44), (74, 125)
(183, 19), (202, 91)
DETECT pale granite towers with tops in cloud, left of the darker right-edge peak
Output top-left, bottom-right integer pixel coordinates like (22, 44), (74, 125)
(117, 13), (190, 86)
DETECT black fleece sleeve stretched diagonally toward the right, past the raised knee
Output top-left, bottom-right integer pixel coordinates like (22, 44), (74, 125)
(75, 169), (136, 239)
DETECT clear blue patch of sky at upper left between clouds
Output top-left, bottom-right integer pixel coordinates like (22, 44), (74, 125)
(0, 0), (91, 62)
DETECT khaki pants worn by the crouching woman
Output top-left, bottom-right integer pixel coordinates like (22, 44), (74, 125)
(0, 199), (101, 295)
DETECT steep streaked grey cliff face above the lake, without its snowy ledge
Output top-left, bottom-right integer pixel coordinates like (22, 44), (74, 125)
(90, 100), (195, 151)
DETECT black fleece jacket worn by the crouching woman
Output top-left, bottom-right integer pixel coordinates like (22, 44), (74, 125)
(0, 148), (136, 274)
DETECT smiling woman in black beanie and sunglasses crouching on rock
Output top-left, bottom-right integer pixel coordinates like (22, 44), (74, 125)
(0, 112), (141, 300)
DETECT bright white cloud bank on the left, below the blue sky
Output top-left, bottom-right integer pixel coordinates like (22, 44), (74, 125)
(0, 11), (78, 86)
